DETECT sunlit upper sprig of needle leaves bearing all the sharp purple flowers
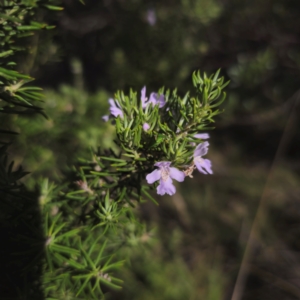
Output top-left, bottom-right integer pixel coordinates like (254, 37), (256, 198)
(98, 71), (227, 198)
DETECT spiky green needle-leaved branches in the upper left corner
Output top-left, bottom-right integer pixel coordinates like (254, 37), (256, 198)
(0, 0), (61, 119)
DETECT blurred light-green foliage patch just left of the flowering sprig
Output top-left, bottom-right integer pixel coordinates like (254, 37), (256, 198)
(14, 86), (114, 187)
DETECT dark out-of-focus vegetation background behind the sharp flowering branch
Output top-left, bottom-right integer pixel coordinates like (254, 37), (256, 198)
(5, 0), (300, 300)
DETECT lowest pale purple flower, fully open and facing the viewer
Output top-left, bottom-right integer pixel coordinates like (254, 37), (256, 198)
(146, 161), (185, 195)
